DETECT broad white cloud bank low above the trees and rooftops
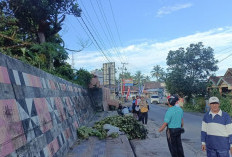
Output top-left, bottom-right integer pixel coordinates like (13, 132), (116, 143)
(69, 27), (232, 75)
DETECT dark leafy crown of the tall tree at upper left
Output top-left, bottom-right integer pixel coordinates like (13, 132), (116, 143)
(0, 0), (81, 43)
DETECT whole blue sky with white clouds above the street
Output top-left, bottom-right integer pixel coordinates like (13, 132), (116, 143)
(60, 0), (232, 76)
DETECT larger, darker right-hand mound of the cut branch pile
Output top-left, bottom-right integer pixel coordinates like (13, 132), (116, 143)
(94, 116), (148, 139)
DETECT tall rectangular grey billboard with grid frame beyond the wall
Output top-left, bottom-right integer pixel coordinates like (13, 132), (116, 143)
(103, 62), (115, 86)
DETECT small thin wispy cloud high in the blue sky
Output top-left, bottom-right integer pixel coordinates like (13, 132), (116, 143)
(157, 3), (193, 17)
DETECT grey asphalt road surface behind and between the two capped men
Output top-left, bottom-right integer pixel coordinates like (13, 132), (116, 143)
(148, 104), (203, 151)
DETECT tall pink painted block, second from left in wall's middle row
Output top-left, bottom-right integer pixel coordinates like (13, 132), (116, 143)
(34, 98), (52, 133)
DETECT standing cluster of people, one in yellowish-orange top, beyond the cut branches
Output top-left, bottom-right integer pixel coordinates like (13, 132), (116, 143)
(132, 95), (149, 125)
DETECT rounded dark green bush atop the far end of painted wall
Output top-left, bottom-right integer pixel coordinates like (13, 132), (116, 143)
(74, 68), (93, 87)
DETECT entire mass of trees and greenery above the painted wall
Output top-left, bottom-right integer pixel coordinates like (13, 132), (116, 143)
(0, 0), (92, 87)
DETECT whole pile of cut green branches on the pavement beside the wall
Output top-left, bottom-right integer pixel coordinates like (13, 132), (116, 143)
(77, 116), (148, 140)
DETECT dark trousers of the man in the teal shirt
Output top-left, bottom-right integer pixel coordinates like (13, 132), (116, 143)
(166, 128), (184, 157)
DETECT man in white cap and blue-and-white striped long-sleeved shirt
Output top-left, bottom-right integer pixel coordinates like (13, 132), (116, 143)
(201, 97), (232, 157)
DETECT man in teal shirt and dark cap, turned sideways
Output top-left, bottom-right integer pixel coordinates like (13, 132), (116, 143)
(159, 95), (184, 157)
